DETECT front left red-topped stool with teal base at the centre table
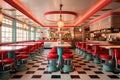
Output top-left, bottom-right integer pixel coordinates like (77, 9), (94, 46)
(47, 53), (58, 72)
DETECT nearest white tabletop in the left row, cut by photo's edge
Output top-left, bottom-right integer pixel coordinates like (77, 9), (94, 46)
(0, 46), (26, 51)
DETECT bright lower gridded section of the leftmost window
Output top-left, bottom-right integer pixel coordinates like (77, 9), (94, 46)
(1, 26), (12, 42)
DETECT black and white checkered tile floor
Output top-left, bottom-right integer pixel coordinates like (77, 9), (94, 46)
(9, 49), (120, 80)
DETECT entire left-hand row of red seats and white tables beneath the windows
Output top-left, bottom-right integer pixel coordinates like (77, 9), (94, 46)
(0, 41), (44, 79)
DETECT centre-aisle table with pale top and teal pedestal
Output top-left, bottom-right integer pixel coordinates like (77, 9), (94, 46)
(51, 42), (71, 69)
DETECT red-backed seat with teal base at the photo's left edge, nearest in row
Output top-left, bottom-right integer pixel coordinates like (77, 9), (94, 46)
(0, 51), (14, 80)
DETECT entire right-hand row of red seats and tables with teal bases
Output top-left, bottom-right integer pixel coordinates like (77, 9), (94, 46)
(76, 42), (120, 71)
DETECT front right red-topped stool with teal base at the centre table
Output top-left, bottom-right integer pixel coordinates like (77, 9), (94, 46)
(62, 53), (73, 72)
